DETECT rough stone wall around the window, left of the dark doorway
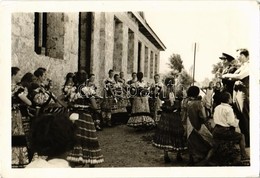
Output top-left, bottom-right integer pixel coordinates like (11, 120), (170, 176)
(11, 13), (78, 95)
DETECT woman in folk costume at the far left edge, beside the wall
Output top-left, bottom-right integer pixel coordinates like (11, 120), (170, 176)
(11, 67), (32, 168)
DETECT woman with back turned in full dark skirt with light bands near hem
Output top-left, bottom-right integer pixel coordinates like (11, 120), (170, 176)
(153, 78), (187, 163)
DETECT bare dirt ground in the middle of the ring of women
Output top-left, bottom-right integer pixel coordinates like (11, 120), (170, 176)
(93, 119), (250, 168)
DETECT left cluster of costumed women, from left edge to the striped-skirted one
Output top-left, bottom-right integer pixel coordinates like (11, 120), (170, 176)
(12, 67), (104, 168)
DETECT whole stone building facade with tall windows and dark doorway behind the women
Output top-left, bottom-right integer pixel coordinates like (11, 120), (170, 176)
(12, 12), (166, 94)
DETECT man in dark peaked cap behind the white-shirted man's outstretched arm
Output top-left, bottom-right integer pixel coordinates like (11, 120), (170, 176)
(219, 53), (237, 96)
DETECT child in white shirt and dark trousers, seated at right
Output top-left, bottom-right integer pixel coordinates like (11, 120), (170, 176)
(212, 92), (249, 160)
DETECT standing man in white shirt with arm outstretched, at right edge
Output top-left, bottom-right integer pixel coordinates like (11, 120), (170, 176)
(222, 49), (250, 147)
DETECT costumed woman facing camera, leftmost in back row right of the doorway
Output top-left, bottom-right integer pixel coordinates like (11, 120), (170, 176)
(101, 69), (116, 127)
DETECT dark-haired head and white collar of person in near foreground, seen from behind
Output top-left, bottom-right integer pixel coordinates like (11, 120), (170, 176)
(26, 113), (76, 168)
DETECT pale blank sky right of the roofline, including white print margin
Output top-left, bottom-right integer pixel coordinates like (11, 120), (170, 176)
(144, 1), (259, 82)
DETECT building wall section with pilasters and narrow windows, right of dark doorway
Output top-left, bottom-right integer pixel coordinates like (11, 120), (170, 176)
(90, 12), (160, 95)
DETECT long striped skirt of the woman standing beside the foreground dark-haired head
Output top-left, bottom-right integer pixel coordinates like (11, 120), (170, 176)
(67, 112), (104, 164)
